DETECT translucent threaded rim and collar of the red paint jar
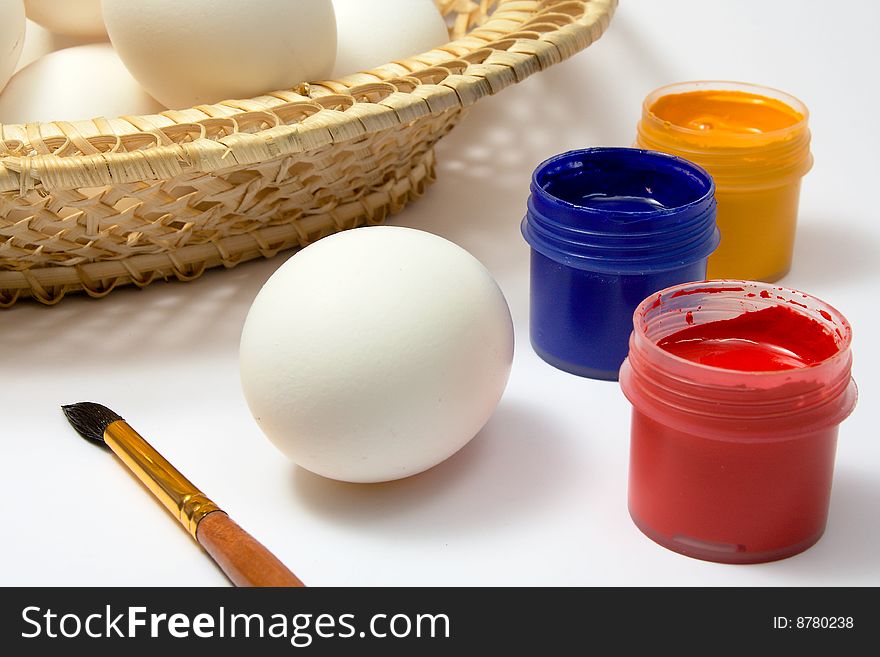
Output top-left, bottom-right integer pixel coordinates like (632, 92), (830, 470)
(620, 280), (856, 440)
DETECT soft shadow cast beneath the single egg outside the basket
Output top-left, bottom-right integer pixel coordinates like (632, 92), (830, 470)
(292, 403), (576, 536)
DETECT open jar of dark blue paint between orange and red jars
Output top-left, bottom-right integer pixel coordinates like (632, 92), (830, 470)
(522, 148), (719, 380)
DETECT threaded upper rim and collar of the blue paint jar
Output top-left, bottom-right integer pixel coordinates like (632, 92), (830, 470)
(522, 148), (719, 273)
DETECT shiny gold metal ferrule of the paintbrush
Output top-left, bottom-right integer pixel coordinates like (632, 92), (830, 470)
(104, 420), (220, 538)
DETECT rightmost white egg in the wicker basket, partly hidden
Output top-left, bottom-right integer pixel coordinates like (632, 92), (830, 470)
(333, 0), (449, 78)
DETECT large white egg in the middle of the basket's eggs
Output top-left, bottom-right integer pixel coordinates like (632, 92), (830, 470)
(103, 0), (336, 109)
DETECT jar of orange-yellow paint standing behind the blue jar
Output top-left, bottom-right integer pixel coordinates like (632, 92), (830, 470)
(636, 82), (813, 282)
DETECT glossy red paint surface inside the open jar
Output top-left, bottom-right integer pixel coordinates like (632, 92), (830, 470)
(657, 306), (838, 372)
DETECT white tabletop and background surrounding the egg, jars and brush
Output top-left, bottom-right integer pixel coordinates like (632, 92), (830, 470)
(0, 0), (880, 585)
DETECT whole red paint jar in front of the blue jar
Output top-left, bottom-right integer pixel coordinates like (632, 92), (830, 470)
(620, 281), (857, 563)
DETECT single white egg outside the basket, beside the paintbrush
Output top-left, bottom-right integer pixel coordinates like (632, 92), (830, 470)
(240, 226), (513, 482)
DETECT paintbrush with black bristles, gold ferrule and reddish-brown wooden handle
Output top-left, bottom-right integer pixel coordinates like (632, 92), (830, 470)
(61, 402), (303, 586)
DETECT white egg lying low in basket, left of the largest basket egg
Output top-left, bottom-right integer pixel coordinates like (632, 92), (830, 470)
(0, 43), (163, 123)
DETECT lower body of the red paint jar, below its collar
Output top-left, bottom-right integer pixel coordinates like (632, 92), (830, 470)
(628, 409), (837, 563)
